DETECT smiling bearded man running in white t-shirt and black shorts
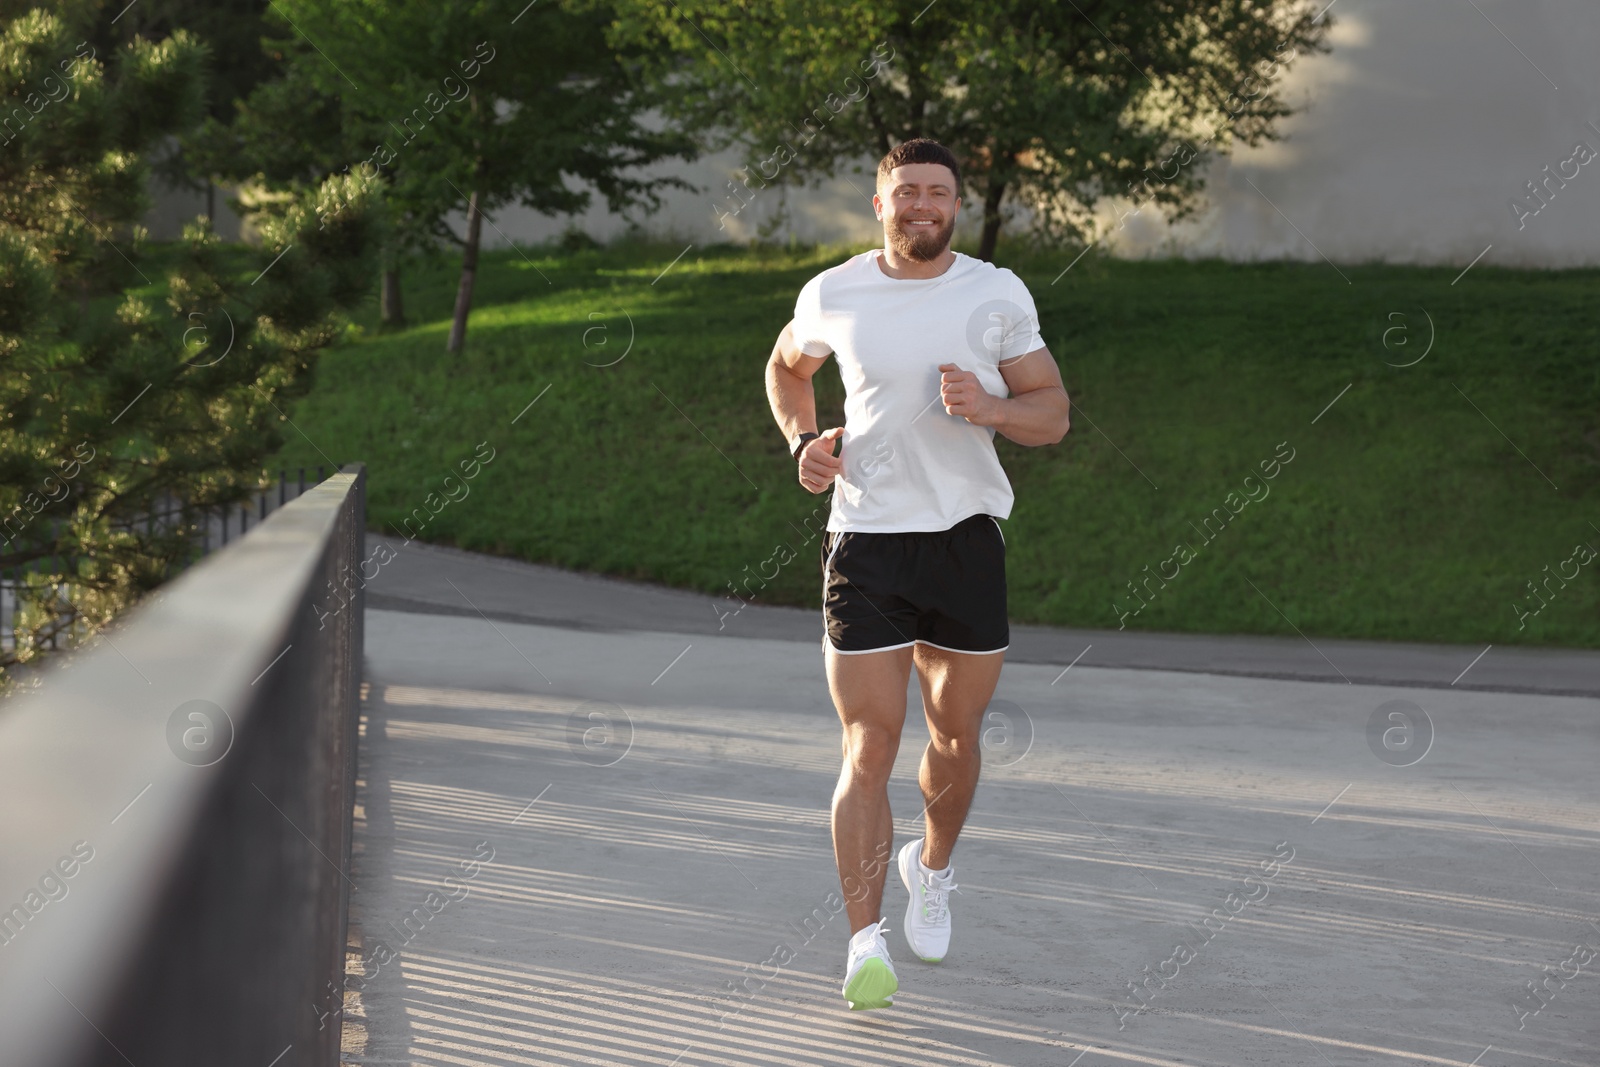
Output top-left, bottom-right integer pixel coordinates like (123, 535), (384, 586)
(766, 138), (1070, 1009)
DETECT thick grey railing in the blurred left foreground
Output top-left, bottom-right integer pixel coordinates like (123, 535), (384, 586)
(0, 464), (366, 1067)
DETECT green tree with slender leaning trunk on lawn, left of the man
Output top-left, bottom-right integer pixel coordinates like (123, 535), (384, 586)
(220, 0), (693, 352)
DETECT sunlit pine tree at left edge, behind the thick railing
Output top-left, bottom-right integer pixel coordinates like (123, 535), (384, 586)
(0, 10), (382, 681)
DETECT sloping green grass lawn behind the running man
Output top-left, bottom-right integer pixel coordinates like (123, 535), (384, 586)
(262, 236), (1600, 646)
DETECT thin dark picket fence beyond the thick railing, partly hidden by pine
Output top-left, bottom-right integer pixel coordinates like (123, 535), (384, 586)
(0, 466), (344, 653)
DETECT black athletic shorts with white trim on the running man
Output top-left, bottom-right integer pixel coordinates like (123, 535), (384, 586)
(822, 515), (1011, 654)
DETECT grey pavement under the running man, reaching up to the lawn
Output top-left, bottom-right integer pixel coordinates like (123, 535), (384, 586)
(346, 545), (1600, 1067)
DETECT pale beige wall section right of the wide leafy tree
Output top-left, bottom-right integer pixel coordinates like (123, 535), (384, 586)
(1117, 0), (1600, 266)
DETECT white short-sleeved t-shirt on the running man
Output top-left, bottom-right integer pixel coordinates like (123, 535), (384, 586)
(794, 248), (1045, 533)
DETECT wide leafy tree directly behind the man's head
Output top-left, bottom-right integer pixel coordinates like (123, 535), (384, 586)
(613, 0), (1328, 259)
